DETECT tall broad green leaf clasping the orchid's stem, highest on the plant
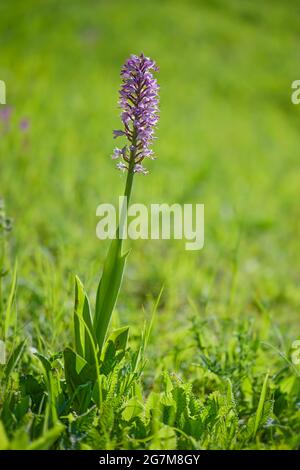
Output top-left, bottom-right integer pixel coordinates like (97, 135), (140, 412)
(93, 238), (128, 353)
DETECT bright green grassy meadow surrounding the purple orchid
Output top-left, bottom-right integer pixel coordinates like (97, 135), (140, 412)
(0, 0), (300, 449)
